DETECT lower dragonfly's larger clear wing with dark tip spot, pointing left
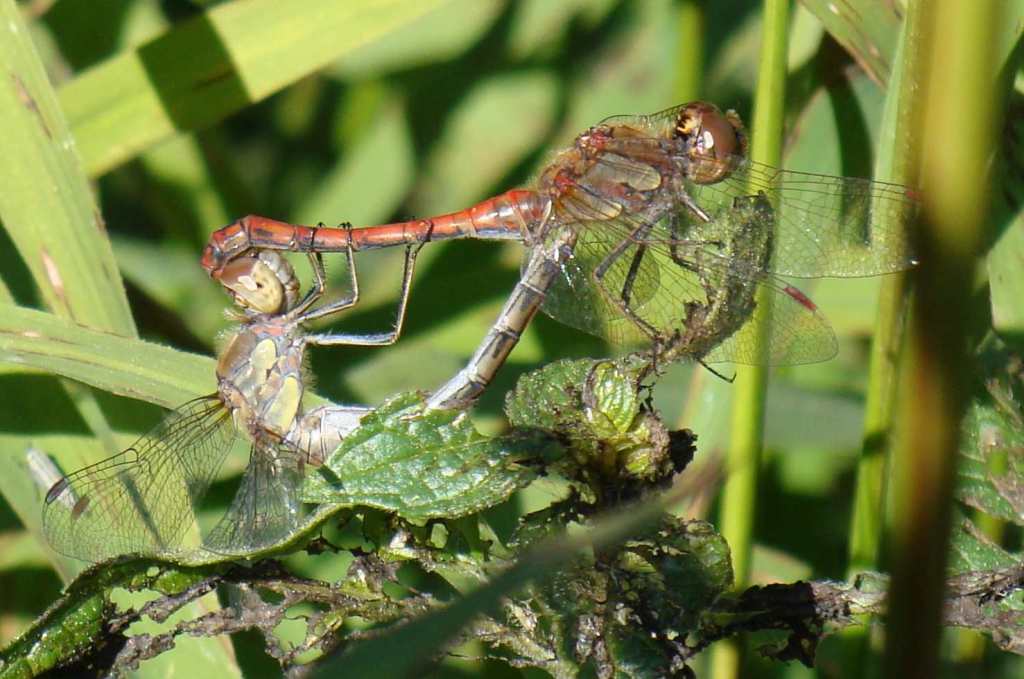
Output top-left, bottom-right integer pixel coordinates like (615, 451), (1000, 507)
(43, 395), (237, 561)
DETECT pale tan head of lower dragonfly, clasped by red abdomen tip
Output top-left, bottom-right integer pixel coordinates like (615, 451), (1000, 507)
(218, 250), (299, 314)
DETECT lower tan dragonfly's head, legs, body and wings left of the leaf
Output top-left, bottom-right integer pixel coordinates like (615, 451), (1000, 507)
(43, 248), (418, 561)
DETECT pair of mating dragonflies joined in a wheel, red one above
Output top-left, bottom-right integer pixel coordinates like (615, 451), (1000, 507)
(44, 101), (916, 560)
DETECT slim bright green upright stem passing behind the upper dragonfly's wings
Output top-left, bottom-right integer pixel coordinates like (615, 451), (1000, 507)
(712, 0), (790, 679)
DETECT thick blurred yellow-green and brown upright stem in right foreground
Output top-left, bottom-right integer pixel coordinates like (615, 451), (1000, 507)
(885, 2), (999, 678)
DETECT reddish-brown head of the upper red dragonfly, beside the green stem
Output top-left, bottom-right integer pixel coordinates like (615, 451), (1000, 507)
(673, 101), (748, 184)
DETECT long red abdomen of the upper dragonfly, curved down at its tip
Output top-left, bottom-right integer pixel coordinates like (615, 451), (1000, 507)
(202, 189), (548, 279)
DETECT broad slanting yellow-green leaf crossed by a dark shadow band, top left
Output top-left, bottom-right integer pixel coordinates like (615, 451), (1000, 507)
(60, 0), (442, 175)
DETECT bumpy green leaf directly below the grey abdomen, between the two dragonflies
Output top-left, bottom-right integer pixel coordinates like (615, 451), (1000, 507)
(303, 393), (547, 521)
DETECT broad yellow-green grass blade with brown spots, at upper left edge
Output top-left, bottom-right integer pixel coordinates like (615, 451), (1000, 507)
(0, 0), (135, 335)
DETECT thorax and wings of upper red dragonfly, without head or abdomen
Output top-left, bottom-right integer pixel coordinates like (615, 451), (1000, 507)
(528, 100), (919, 365)
